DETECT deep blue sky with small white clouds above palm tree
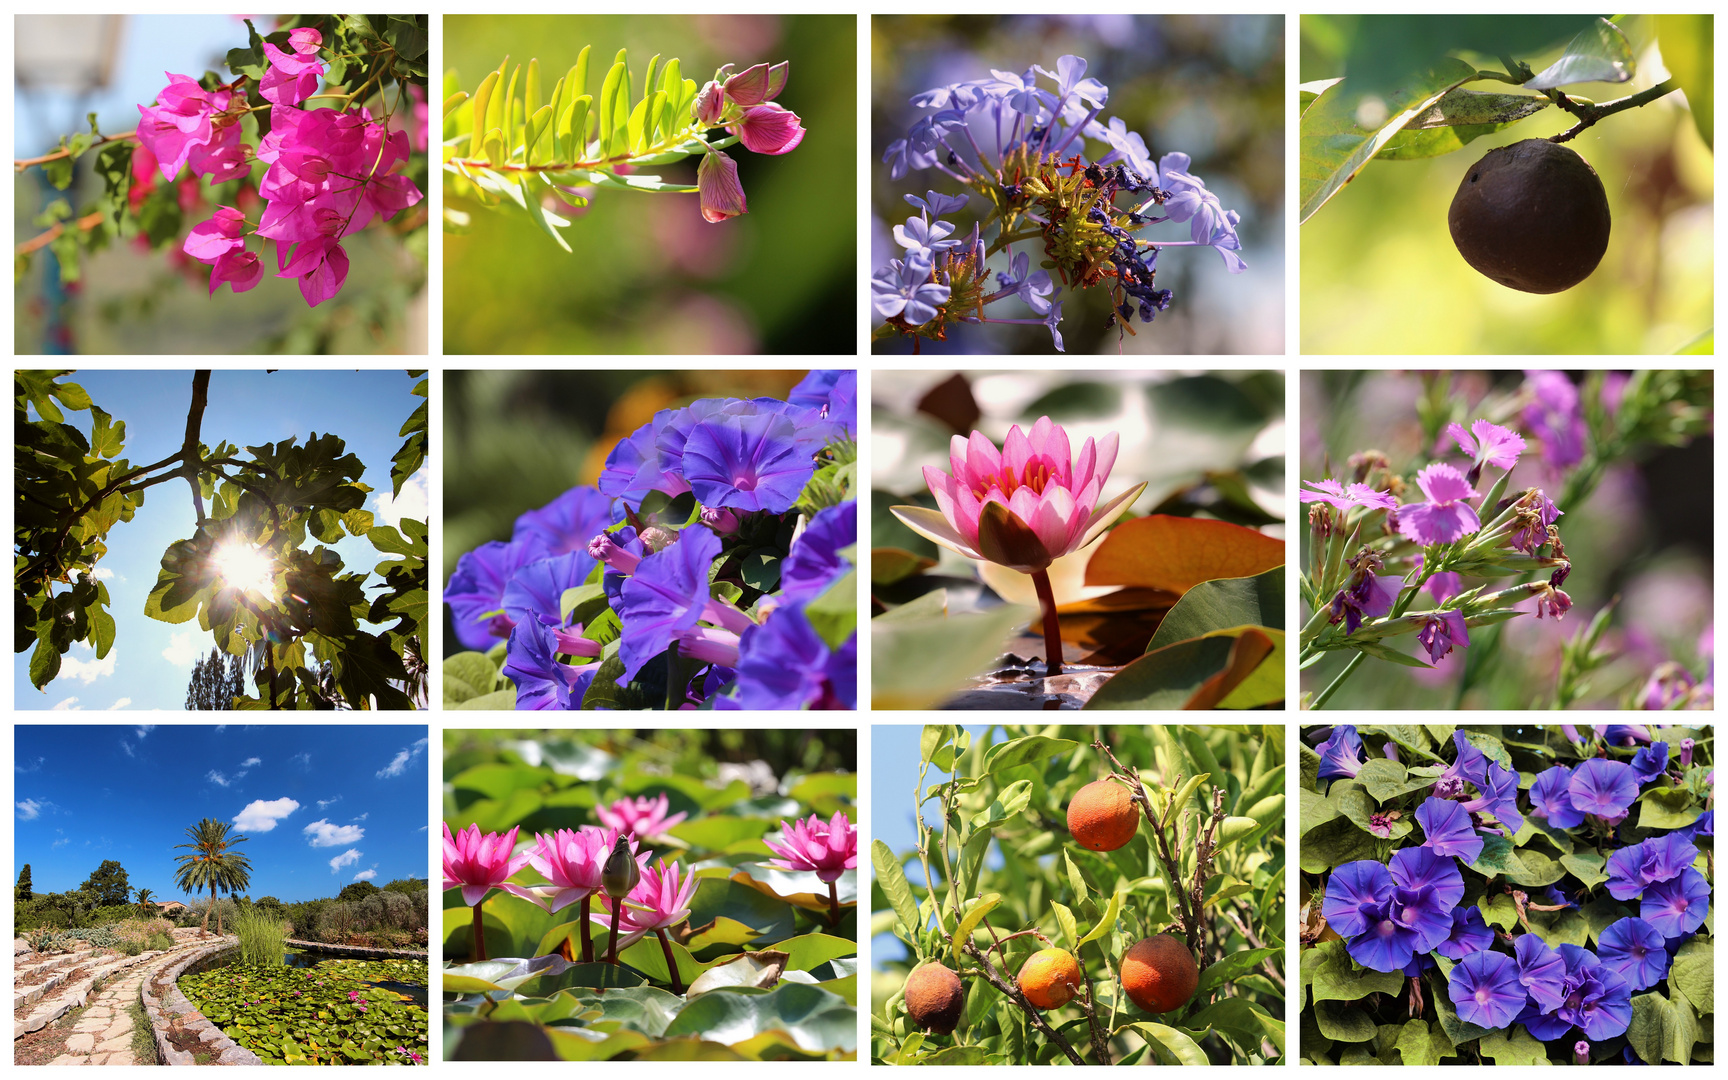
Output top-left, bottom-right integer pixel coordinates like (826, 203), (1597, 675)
(12, 724), (430, 902)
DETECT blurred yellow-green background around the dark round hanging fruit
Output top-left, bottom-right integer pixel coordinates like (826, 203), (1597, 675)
(1299, 16), (1716, 354)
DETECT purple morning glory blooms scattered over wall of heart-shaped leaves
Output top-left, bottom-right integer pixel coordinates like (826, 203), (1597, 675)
(1315, 724), (1714, 1043)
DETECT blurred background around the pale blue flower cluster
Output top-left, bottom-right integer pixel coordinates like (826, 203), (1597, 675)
(869, 14), (1286, 354)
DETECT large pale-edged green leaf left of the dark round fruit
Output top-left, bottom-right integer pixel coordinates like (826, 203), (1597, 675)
(1296, 57), (1476, 221)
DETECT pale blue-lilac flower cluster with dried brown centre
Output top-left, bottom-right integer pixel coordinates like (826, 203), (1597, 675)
(871, 55), (1248, 351)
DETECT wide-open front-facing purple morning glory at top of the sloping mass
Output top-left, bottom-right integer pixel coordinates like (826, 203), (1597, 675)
(683, 411), (816, 513)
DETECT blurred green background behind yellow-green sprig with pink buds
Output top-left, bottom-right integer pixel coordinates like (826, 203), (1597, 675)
(444, 14), (857, 354)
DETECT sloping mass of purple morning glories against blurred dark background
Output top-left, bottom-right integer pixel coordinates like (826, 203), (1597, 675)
(444, 372), (857, 710)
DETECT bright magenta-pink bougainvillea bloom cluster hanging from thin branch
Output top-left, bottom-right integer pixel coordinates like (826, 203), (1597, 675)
(138, 28), (423, 308)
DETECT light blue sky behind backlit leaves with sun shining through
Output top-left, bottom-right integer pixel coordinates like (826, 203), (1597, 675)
(12, 370), (429, 710)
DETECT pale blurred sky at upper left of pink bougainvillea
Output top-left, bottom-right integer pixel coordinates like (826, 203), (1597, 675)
(12, 16), (240, 157)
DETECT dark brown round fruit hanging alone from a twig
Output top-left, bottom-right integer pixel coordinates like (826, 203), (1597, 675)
(1446, 138), (1609, 292)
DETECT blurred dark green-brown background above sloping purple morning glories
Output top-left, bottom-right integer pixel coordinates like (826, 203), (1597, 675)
(439, 366), (822, 653)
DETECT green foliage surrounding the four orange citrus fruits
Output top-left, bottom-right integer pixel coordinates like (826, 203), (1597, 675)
(871, 724), (1284, 1064)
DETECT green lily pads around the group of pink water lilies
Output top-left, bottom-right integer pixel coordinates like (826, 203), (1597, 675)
(442, 729), (857, 1061)
